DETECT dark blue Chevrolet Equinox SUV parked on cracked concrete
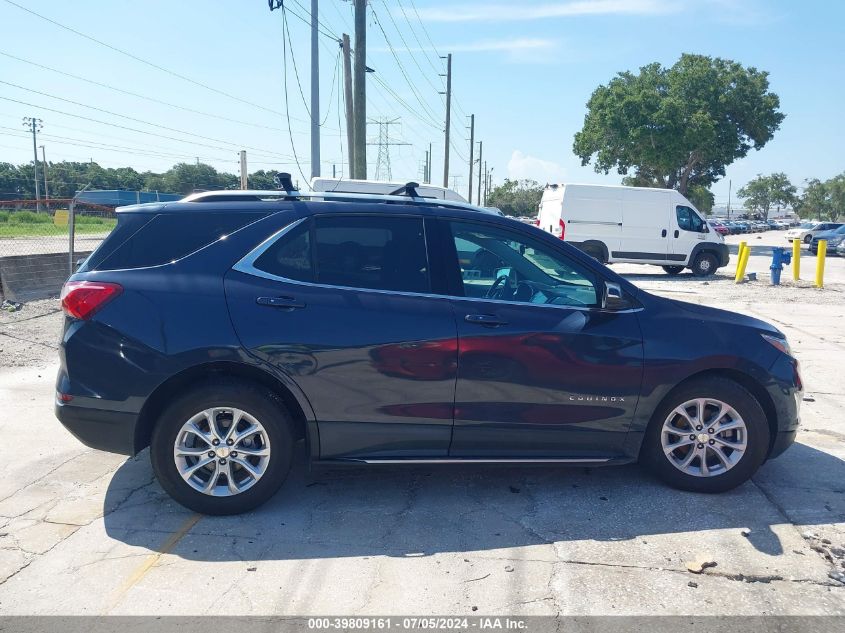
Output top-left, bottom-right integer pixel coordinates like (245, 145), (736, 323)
(56, 185), (802, 514)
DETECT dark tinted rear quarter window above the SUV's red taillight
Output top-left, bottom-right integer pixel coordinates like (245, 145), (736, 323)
(88, 212), (266, 270)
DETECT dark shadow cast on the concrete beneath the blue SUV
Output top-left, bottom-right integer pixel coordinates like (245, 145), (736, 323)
(104, 444), (845, 561)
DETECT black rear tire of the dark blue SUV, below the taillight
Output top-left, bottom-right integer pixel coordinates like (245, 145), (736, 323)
(150, 379), (294, 515)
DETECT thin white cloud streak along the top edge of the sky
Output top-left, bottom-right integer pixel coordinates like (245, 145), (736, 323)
(406, 0), (682, 22)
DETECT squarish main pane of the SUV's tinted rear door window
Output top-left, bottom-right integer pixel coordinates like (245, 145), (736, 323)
(314, 216), (429, 292)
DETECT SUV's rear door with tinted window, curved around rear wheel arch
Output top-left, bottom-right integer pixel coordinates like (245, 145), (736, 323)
(225, 212), (457, 459)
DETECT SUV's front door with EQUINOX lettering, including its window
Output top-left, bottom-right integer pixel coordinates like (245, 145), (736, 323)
(441, 219), (643, 460)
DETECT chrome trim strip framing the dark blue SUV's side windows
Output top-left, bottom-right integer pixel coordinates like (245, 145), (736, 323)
(232, 216), (642, 314)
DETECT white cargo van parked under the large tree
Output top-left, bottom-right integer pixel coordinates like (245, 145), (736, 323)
(537, 184), (729, 277)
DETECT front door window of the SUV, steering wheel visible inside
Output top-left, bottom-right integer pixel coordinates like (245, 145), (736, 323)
(449, 222), (599, 307)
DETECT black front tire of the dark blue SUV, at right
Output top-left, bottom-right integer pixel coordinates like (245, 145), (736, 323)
(640, 377), (770, 493)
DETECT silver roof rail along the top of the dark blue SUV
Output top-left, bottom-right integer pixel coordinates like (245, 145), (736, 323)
(180, 188), (495, 215)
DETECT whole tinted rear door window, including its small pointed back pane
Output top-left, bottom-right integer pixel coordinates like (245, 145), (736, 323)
(254, 215), (430, 293)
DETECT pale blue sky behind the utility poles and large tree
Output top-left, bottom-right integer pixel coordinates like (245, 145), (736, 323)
(0, 0), (845, 203)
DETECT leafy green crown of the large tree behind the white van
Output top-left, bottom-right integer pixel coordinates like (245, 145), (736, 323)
(573, 54), (784, 195)
